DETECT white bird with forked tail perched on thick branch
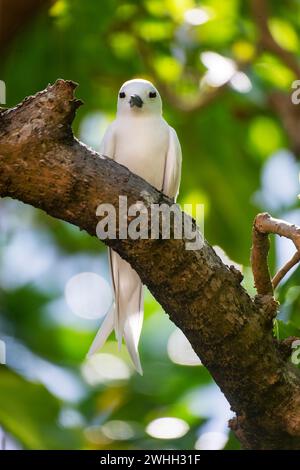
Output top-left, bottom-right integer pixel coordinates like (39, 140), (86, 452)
(88, 79), (181, 374)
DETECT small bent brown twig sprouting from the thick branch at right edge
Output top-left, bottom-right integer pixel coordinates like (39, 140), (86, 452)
(251, 213), (300, 295)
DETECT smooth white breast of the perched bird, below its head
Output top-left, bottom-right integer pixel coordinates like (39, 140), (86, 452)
(114, 116), (169, 190)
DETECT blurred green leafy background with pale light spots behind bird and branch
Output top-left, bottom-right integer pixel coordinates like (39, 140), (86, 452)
(0, 0), (300, 449)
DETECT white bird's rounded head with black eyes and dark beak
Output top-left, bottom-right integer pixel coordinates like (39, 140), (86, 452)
(118, 78), (162, 115)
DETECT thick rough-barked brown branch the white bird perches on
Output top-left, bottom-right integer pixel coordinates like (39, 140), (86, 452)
(0, 80), (300, 449)
